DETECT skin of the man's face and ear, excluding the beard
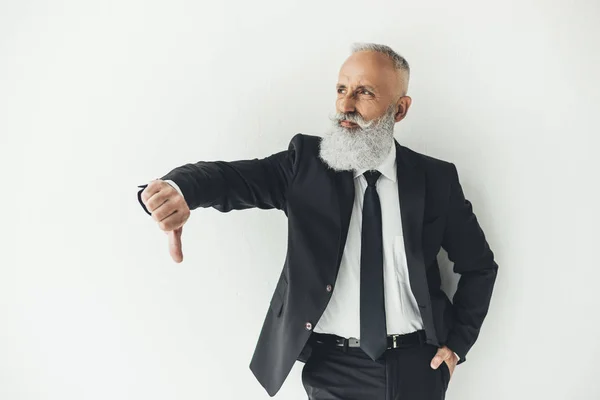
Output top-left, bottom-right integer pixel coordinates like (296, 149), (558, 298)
(335, 51), (411, 128)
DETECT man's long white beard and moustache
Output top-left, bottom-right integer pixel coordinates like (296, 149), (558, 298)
(319, 107), (396, 171)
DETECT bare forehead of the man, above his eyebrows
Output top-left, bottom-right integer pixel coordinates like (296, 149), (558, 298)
(338, 51), (398, 88)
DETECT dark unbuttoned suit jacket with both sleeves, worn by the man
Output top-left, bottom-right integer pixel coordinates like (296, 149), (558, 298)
(138, 134), (498, 396)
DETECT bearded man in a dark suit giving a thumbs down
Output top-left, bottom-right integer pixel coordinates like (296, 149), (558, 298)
(138, 44), (498, 400)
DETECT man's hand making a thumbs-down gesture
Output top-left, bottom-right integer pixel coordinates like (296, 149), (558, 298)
(141, 179), (190, 263)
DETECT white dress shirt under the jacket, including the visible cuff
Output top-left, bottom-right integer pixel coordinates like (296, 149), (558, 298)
(152, 143), (458, 357)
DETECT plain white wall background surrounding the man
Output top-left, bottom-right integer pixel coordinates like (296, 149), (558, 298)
(0, 0), (600, 400)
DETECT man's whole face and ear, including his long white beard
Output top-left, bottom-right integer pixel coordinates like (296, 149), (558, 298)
(319, 52), (411, 171)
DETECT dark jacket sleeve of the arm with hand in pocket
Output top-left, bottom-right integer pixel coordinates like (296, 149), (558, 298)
(442, 164), (498, 364)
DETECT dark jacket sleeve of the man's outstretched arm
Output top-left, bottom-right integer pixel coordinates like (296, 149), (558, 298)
(138, 134), (302, 214)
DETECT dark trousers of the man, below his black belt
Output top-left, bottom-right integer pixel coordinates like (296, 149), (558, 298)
(302, 332), (450, 400)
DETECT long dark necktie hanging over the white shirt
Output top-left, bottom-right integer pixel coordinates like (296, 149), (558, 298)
(360, 171), (387, 360)
